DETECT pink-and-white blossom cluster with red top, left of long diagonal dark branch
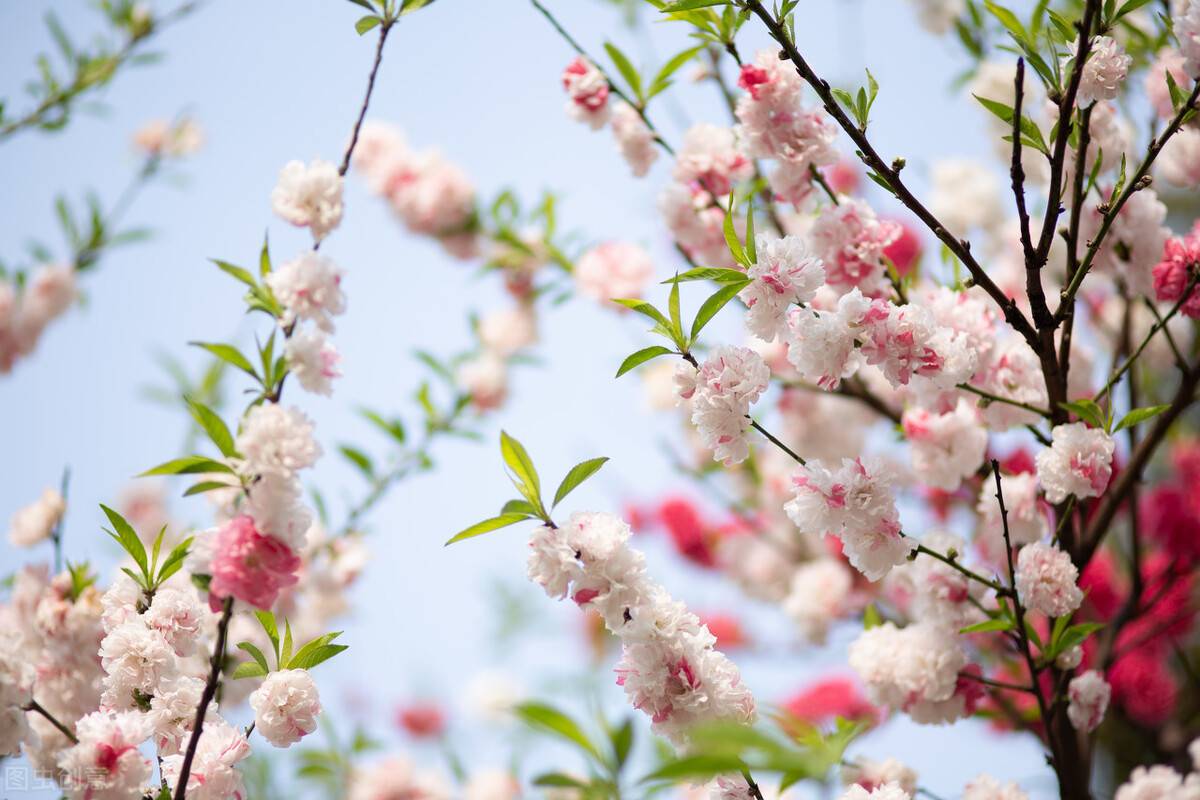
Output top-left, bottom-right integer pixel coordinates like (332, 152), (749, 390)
(722, 50), (838, 170)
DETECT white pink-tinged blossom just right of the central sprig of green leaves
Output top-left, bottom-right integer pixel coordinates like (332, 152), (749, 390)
(738, 234), (824, 342)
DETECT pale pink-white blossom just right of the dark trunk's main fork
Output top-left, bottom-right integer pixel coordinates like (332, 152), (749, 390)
(1037, 422), (1116, 503)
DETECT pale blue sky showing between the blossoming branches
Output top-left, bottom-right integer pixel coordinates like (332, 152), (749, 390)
(0, 0), (1051, 798)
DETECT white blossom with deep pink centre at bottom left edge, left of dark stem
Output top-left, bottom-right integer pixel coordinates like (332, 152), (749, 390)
(59, 711), (151, 800)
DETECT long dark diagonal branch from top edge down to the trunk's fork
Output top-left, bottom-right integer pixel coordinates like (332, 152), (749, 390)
(743, 0), (1042, 350)
